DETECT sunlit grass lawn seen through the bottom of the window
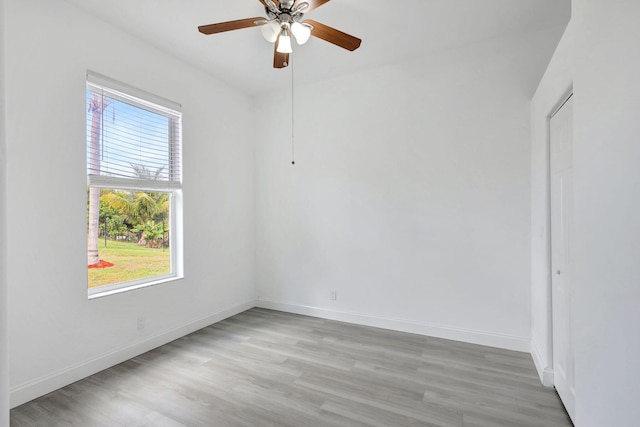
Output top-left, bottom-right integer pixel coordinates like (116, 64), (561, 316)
(88, 239), (171, 288)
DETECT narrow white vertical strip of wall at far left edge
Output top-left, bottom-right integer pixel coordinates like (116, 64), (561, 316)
(0, 0), (9, 426)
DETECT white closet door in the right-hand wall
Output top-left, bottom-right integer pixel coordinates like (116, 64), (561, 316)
(550, 94), (575, 421)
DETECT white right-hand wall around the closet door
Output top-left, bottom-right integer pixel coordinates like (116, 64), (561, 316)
(532, 0), (640, 426)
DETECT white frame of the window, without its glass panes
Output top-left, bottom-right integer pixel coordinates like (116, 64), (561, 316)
(85, 71), (184, 299)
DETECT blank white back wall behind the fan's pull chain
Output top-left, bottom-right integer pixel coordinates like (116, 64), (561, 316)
(256, 29), (562, 351)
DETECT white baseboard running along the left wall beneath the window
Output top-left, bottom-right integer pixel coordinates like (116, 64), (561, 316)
(10, 301), (255, 408)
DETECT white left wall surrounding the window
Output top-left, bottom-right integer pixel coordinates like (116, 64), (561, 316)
(3, 0), (255, 405)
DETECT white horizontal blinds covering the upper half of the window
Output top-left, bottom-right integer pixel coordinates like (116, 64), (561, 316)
(86, 73), (182, 187)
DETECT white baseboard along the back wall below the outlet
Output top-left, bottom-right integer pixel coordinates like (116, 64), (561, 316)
(256, 298), (531, 353)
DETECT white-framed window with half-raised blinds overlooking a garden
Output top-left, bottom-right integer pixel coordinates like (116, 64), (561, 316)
(86, 73), (182, 298)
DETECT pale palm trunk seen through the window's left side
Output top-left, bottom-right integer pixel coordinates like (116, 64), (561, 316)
(87, 93), (104, 265)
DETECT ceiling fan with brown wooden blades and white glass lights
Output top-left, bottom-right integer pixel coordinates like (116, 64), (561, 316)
(198, 0), (362, 68)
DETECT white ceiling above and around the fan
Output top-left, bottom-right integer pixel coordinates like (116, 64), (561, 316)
(61, 0), (571, 94)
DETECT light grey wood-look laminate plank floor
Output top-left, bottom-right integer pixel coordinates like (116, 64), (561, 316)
(11, 308), (571, 427)
